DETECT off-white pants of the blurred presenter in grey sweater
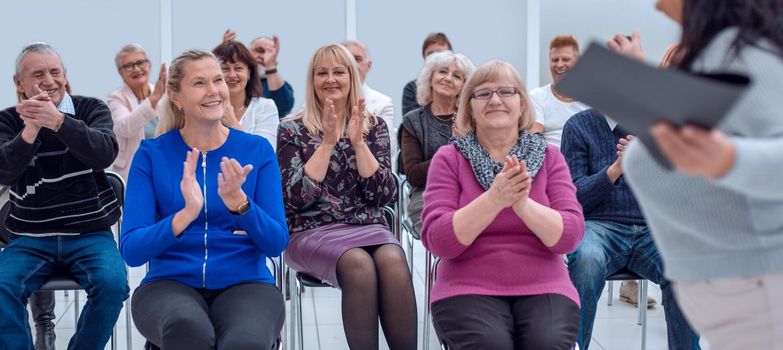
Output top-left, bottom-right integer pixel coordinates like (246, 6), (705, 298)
(674, 273), (783, 350)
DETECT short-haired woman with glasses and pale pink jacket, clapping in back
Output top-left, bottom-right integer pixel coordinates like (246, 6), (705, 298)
(106, 44), (166, 180)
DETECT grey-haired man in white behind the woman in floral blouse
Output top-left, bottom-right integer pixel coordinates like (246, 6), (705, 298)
(343, 40), (397, 152)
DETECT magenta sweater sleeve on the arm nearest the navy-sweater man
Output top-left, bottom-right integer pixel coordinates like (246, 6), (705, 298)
(544, 146), (585, 254)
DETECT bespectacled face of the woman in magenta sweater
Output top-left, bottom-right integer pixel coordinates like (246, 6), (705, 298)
(470, 79), (522, 132)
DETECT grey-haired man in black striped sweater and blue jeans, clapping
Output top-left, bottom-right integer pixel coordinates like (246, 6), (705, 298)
(0, 42), (128, 349)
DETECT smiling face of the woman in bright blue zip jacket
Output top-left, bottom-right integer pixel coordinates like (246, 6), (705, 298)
(169, 57), (229, 122)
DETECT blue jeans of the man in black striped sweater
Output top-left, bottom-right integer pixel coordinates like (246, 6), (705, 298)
(0, 231), (128, 350)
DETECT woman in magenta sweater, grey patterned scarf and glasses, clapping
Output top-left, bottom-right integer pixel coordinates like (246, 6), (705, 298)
(421, 61), (585, 350)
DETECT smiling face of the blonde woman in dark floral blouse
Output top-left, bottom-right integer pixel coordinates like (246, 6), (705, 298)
(313, 56), (351, 105)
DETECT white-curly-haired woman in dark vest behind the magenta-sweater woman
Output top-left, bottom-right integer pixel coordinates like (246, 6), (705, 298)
(398, 51), (475, 235)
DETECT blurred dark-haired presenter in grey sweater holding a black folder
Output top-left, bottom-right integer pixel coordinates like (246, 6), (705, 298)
(610, 0), (783, 349)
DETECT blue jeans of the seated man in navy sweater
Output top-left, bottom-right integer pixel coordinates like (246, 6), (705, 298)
(568, 220), (700, 350)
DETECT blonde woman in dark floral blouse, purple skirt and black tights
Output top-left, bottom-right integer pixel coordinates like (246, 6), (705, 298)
(277, 44), (416, 350)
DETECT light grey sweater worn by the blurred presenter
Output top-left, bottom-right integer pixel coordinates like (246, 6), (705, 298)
(623, 29), (783, 282)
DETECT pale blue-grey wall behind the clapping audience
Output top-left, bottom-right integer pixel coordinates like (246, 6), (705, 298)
(0, 0), (678, 119)
